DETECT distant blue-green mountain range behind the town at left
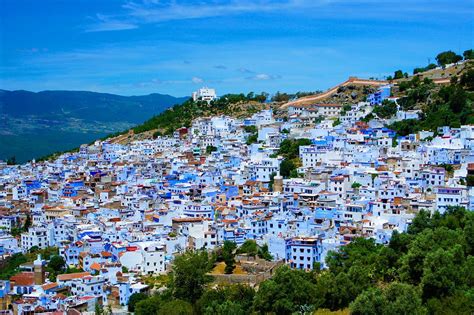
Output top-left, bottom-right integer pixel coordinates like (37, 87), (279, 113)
(0, 90), (187, 162)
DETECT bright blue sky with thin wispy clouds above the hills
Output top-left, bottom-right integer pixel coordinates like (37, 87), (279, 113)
(0, 0), (474, 96)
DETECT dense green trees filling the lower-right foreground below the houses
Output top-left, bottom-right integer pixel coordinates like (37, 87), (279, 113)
(130, 207), (474, 315)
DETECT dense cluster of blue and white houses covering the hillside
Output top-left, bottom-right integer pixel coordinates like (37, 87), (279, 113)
(0, 91), (474, 313)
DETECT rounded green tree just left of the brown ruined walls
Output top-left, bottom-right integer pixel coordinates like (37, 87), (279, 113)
(171, 251), (212, 303)
